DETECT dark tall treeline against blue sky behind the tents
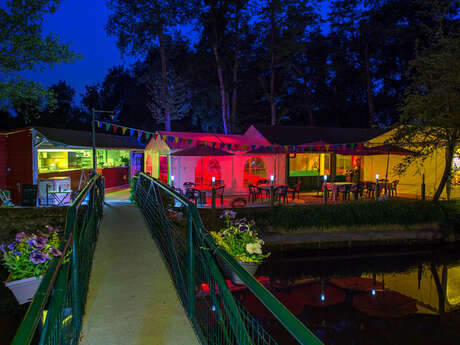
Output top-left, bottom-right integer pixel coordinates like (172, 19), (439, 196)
(1, 0), (459, 133)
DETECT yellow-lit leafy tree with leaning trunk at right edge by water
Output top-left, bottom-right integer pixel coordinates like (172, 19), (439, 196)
(392, 34), (460, 200)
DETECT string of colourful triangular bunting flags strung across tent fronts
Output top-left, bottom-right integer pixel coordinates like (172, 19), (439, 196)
(96, 121), (365, 155)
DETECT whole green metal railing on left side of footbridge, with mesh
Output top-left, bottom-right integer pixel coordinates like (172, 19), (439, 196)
(11, 175), (104, 345)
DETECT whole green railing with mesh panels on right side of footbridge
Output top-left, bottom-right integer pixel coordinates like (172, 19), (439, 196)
(133, 174), (322, 345)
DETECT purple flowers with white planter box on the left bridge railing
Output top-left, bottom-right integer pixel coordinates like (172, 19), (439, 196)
(0, 226), (62, 304)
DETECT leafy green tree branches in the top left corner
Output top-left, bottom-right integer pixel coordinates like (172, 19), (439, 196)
(0, 0), (79, 121)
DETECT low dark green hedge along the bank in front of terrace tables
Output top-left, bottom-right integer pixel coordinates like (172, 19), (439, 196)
(200, 200), (460, 232)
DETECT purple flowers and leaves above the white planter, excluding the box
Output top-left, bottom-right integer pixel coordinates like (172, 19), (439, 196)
(0, 226), (67, 280)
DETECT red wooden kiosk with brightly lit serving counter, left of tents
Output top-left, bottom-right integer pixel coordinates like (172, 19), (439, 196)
(0, 127), (144, 204)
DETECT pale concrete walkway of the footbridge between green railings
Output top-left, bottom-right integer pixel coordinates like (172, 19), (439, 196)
(80, 202), (199, 345)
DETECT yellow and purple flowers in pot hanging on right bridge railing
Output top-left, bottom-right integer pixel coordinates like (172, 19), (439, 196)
(210, 210), (270, 284)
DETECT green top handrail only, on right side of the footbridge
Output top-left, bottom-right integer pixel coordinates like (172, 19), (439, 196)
(136, 173), (323, 345)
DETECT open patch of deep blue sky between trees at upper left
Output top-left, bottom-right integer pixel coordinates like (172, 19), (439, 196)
(23, 0), (131, 99)
